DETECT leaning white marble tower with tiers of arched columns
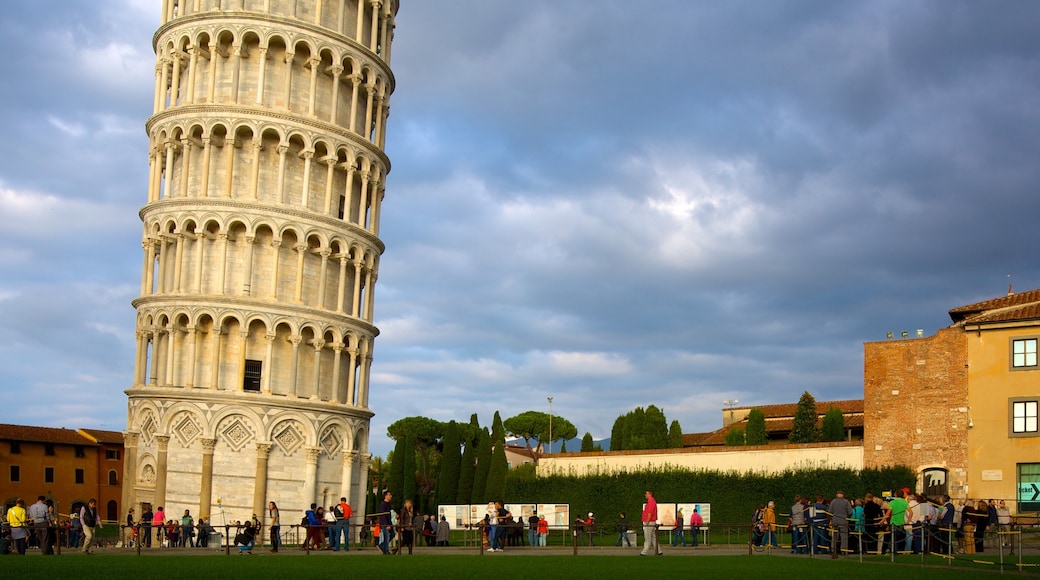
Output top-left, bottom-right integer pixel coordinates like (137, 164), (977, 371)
(123, 0), (397, 525)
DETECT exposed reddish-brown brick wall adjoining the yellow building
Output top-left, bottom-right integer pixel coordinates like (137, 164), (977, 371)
(863, 327), (968, 496)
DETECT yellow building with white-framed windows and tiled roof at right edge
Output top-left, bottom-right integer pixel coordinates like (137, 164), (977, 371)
(950, 290), (1040, 512)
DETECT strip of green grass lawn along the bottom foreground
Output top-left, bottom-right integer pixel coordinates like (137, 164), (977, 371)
(0, 550), (1040, 580)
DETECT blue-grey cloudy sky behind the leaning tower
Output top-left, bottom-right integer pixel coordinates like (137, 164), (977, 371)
(0, 0), (1040, 454)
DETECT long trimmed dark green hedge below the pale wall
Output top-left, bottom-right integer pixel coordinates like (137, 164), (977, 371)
(503, 467), (916, 526)
